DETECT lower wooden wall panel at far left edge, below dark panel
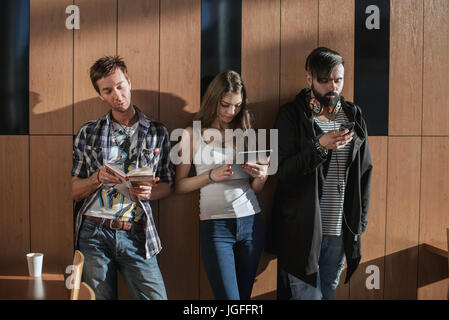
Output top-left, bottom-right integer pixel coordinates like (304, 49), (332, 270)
(0, 136), (30, 266)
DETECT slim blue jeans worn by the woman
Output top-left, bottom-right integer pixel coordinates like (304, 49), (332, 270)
(200, 213), (265, 300)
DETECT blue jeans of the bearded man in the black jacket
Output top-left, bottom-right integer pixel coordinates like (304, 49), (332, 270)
(288, 235), (345, 300)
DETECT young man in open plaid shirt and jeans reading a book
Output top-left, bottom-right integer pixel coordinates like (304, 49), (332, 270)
(72, 56), (174, 299)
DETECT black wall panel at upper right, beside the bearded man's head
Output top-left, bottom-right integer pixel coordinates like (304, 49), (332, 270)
(354, 0), (390, 136)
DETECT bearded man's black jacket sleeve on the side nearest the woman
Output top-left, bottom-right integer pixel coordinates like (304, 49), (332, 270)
(275, 106), (326, 181)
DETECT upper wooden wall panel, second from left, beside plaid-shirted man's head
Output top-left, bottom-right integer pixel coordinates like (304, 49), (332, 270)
(73, 0), (117, 133)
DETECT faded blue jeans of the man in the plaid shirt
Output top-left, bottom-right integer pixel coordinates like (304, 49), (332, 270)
(79, 220), (167, 300)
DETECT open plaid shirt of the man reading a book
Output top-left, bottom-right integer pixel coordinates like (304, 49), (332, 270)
(72, 106), (174, 259)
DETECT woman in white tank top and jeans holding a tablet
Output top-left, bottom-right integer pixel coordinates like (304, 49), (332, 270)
(176, 71), (268, 300)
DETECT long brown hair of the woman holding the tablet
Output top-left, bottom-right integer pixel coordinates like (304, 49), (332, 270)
(194, 70), (251, 131)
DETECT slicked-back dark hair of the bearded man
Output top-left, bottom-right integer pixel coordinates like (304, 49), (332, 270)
(306, 47), (345, 77)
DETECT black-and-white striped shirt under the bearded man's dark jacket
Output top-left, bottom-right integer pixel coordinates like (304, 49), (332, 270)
(314, 111), (353, 236)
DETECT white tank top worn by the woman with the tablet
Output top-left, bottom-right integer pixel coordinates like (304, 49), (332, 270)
(193, 126), (261, 220)
